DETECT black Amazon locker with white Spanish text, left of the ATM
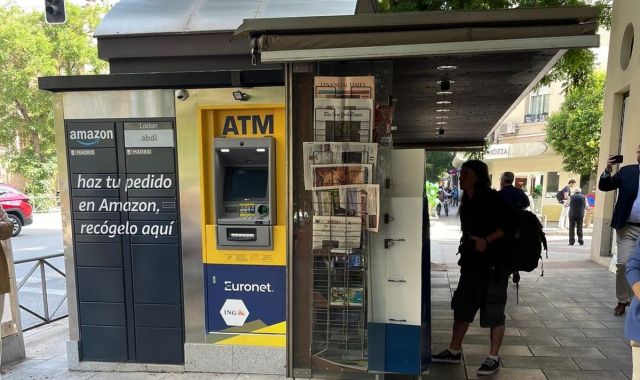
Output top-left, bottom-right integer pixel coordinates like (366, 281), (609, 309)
(65, 119), (184, 364)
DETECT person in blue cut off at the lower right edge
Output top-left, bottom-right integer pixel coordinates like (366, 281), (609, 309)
(624, 240), (640, 380)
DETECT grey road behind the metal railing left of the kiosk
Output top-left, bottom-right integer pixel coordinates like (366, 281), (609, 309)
(11, 211), (67, 329)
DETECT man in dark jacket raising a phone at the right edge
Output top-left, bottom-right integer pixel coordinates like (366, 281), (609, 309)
(598, 146), (640, 316)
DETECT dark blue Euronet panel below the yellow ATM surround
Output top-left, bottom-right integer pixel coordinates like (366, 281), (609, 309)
(205, 264), (286, 332)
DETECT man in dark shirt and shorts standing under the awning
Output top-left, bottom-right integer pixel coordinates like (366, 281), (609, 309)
(431, 160), (514, 375)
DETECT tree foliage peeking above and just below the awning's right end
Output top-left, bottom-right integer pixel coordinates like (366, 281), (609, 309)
(378, 0), (613, 87)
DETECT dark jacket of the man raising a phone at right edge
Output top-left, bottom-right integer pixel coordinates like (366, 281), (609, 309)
(598, 164), (640, 229)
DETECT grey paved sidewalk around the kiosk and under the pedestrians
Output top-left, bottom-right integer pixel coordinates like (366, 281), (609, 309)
(2, 216), (631, 380)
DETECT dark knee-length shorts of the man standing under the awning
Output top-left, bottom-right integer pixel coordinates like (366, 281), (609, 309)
(451, 268), (509, 327)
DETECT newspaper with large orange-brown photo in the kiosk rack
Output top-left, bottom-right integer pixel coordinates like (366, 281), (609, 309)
(311, 164), (373, 190)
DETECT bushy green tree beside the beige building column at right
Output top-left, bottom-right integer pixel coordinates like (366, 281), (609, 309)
(547, 72), (605, 176)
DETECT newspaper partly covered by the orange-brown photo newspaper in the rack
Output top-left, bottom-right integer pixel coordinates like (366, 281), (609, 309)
(302, 142), (378, 190)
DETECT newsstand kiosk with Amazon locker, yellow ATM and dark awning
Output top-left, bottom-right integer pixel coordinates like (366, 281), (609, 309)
(40, 0), (598, 378)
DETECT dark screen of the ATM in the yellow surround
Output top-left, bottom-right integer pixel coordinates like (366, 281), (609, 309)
(224, 167), (269, 201)
